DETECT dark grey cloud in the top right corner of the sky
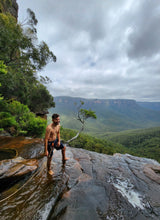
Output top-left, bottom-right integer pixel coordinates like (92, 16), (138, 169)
(128, 0), (160, 59)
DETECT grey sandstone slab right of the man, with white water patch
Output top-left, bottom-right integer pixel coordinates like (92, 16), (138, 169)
(48, 148), (160, 220)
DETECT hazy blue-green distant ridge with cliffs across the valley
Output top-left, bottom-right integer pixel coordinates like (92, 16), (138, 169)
(49, 96), (160, 135)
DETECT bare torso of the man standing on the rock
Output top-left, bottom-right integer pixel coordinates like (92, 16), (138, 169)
(46, 123), (60, 141)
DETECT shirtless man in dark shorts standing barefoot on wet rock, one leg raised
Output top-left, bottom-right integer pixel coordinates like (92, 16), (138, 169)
(44, 114), (68, 175)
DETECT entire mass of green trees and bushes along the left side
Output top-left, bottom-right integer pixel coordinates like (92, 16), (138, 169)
(0, 4), (56, 136)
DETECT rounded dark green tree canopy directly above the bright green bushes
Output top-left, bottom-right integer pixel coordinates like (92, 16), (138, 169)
(0, 65), (54, 112)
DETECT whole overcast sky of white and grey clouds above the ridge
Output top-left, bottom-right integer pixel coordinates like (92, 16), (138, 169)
(17, 0), (160, 101)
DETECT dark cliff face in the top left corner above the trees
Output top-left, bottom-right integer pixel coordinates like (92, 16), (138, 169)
(0, 0), (18, 19)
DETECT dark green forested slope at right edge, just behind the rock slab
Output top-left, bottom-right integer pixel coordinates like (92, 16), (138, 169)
(107, 127), (160, 162)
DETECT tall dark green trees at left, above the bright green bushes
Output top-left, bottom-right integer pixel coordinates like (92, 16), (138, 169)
(0, 9), (56, 112)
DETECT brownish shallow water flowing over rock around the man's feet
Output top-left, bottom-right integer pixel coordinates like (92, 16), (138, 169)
(0, 138), (67, 220)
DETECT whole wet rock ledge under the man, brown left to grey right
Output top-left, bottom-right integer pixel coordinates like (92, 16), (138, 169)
(0, 137), (160, 220)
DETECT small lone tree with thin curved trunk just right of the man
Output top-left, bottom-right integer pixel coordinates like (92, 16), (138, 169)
(67, 101), (97, 143)
